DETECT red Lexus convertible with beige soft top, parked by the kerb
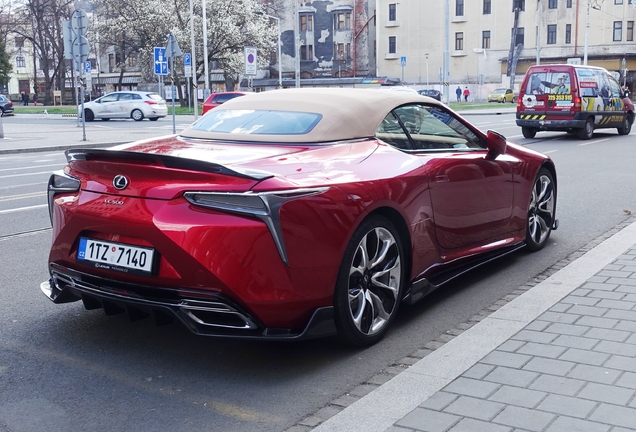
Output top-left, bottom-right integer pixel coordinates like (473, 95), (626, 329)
(41, 89), (557, 346)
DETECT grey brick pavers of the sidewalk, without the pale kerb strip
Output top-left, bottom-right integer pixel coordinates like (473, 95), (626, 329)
(389, 245), (636, 432)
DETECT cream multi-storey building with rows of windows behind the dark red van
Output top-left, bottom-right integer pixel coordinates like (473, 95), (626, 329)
(376, 0), (636, 92)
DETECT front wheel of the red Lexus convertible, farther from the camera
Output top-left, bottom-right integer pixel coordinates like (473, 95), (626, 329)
(526, 168), (556, 251)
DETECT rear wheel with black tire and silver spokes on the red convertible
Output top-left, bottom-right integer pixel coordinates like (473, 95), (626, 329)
(333, 215), (407, 346)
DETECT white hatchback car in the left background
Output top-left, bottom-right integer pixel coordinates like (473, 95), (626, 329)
(77, 91), (168, 121)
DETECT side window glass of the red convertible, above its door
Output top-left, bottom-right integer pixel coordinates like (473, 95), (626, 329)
(376, 105), (485, 151)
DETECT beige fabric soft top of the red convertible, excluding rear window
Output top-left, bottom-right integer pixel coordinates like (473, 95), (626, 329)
(181, 88), (439, 143)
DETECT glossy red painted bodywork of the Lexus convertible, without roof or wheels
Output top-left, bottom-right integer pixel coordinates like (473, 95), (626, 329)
(49, 137), (545, 328)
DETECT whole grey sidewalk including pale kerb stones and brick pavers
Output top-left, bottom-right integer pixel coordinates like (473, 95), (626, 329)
(314, 222), (636, 432)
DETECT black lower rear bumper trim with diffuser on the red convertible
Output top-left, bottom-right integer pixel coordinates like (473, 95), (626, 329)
(40, 264), (336, 340)
